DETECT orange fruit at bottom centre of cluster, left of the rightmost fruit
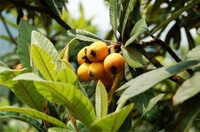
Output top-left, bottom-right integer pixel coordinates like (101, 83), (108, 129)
(88, 62), (105, 80)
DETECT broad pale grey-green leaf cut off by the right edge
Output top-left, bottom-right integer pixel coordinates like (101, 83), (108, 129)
(173, 71), (200, 105)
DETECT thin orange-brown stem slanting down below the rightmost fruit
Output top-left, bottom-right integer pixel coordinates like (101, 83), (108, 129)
(108, 70), (124, 104)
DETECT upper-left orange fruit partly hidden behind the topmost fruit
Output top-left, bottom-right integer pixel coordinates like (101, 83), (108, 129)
(77, 46), (89, 65)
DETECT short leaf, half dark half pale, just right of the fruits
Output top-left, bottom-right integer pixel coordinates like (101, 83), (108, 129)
(122, 47), (144, 68)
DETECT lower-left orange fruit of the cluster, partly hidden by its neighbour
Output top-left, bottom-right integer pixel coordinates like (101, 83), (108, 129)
(77, 63), (91, 82)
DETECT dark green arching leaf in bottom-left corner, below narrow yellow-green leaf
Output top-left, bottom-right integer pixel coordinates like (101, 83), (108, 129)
(0, 112), (46, 132)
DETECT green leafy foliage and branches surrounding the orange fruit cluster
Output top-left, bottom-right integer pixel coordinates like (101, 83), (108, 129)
(0, 0), (200, 132)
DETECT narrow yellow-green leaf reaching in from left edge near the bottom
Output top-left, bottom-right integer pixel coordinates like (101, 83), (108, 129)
(0, 106), (67, 128)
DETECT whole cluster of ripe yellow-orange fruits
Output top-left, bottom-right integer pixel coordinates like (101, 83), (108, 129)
(77, 42), (125, 88)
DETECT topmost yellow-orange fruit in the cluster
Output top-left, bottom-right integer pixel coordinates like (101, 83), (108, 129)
(87, 42), (108, 61)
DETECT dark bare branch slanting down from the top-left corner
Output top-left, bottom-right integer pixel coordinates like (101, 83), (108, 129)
(8, 0), (71, 30)
